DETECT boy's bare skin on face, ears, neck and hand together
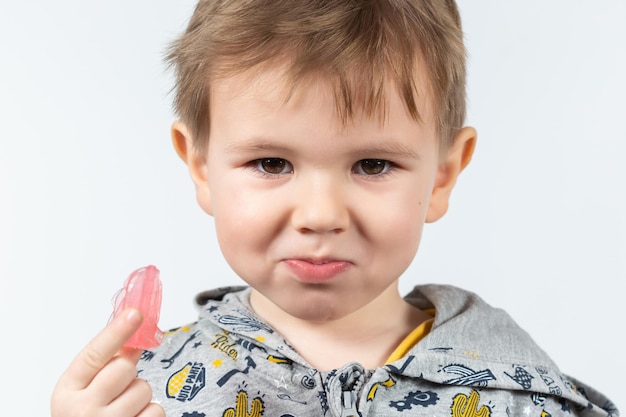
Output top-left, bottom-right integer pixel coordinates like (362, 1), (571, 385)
(51, 61), (476, 417)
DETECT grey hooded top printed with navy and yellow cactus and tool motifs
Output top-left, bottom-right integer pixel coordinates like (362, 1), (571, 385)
(138, 285), (619, 417)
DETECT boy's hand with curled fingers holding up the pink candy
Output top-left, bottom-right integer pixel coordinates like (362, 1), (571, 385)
(51, 309), (165, 417)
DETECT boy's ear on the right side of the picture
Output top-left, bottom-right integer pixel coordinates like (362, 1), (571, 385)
(426, 127), (476, 223)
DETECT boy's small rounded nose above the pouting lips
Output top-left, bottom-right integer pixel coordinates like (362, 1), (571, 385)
(291, 176), (350, 233)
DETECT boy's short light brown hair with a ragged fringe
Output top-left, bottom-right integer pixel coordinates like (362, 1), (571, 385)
(166, 0), (465, 150)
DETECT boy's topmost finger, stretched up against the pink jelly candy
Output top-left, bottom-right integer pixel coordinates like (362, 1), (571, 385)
(61, 309), (143, 389)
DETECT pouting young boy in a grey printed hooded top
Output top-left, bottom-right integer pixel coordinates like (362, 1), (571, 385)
(52, 0), (618, 417)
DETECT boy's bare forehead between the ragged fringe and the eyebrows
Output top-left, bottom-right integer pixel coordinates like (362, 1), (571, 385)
(209, 61), (437, 160)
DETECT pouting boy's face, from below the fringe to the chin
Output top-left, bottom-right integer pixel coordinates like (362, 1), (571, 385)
(174, 65), (471, 321)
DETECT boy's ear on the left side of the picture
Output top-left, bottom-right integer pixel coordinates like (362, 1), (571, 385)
(172, 120), (213, 215)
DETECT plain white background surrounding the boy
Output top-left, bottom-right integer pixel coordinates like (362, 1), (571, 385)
(0, 0), (626, 416)
